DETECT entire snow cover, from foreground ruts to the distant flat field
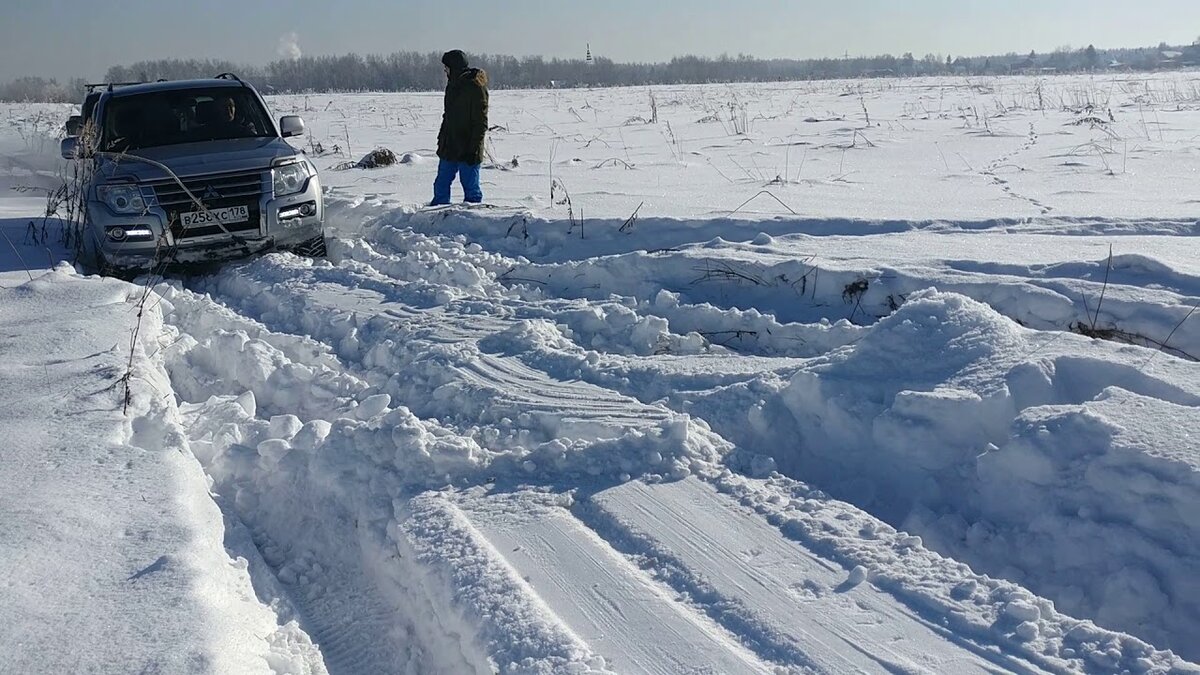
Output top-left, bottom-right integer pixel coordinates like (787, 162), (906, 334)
(0, 73), (1200, 673)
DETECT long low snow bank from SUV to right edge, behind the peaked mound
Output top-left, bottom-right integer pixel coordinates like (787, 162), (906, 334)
(330, 198), (1200, 357)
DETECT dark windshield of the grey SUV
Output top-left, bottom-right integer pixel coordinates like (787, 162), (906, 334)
(101, 88), (275, 153)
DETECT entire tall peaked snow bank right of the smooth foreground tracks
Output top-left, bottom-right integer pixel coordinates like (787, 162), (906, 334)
(775, 292), (1200, 658)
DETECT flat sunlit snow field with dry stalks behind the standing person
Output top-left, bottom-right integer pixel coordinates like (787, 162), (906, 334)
(285, 72), (1200, 220)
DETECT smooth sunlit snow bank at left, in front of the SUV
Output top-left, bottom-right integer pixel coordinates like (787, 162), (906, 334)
(0, 265), (325, 674)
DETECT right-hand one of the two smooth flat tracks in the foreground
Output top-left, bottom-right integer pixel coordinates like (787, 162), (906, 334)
(572, 478), (1043, 673)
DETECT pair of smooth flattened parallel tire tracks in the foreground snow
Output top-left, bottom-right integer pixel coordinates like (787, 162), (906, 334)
(460, 477), (1040, 673)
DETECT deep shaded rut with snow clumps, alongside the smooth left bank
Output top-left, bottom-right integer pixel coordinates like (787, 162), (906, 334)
(166, 284), (602, 674)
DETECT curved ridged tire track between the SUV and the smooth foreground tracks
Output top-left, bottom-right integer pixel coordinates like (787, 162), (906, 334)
(189, 257), (674, 446)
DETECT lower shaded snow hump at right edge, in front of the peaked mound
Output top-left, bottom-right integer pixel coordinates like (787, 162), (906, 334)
(964, 387), (1200, 656)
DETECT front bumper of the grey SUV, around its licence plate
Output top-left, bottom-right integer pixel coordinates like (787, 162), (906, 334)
(88, 171), (325, 269)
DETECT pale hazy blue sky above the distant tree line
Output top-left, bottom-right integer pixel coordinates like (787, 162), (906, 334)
(7, 0), (1200, 80)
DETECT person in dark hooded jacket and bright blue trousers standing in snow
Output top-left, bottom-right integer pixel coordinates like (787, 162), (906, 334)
(430, 49), (487, 205)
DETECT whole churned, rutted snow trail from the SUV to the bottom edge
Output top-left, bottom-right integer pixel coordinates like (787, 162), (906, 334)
(152, 195), (1187, 673)
